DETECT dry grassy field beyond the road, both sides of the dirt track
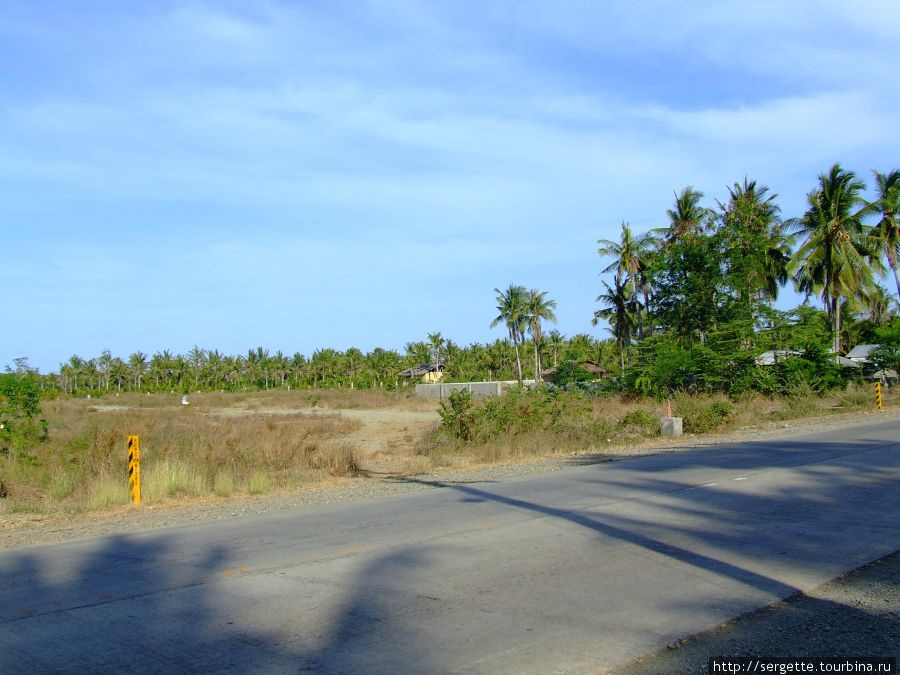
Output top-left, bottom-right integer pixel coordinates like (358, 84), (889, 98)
(0, 386), (898, 517)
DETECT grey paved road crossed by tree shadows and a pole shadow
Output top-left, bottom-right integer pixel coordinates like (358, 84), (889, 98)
(0, 422), (900, 675)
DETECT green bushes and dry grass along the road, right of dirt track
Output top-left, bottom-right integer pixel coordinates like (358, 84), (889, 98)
(420, 383), (900, 467)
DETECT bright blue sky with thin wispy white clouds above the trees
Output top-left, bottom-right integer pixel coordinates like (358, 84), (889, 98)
(0, 0), (900, 372)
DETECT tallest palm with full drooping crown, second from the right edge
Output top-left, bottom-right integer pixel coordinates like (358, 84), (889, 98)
(788, 164), (883, 355)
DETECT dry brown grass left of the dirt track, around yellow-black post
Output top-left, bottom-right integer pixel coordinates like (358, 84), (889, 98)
(0, 394), (361, 512)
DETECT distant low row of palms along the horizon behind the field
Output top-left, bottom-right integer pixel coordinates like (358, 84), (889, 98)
(15, 331), (614, 395)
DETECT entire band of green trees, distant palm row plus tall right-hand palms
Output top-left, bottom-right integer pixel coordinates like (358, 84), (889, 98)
(8, 164), (900, 395)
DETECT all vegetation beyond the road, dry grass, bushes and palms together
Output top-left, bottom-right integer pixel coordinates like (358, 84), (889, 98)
(0, 164), (900, 513)
